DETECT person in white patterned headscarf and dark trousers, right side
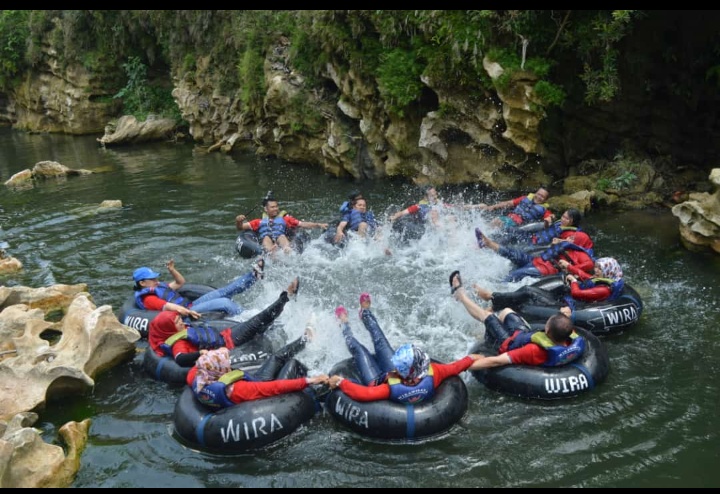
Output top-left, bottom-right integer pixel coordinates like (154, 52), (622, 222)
(472, 257), (625, 315)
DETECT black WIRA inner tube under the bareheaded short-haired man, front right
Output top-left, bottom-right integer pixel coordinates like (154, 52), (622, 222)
(470, 328), (610, 400)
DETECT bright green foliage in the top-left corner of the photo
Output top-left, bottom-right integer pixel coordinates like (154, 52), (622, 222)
(0, 10), (30, 89)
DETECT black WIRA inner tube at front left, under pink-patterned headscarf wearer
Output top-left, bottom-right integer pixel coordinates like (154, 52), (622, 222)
(173, 372), (318, 454)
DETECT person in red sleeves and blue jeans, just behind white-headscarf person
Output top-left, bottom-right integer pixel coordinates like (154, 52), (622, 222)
(475, 229), (595, 281)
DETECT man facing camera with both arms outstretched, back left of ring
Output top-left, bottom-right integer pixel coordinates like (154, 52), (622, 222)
(235, 197), (328, 254)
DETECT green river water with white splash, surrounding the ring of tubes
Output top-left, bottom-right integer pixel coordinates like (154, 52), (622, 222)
(0, 129), (720, 487)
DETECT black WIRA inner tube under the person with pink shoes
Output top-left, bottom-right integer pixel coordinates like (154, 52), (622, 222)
(325, 358), (468, 442)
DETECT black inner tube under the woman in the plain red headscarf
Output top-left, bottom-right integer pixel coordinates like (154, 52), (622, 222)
(142, 332), (274, 384)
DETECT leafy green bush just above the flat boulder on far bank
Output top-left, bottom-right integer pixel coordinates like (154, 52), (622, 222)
(113, 57), (180, 122)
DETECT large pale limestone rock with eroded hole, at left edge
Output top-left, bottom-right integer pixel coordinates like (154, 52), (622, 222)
(0, 285), (140, 419)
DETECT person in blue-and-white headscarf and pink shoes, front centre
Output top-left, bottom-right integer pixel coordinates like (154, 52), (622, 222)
(329, 293), (479, 404)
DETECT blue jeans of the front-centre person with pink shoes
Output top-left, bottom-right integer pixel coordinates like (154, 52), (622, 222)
(343, 309), (395, 386)
